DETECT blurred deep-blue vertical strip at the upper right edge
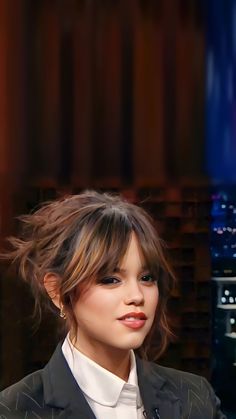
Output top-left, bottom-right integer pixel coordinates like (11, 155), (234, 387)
(206, 0), (236, 184)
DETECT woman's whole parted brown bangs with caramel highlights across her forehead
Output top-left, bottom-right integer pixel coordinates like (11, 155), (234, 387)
(62, 201), (169, 294)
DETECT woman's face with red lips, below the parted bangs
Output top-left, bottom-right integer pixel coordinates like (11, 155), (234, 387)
(74, 234), (158, 360)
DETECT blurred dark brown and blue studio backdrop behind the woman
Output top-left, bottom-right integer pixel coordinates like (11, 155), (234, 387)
(0, 0), (236, 418)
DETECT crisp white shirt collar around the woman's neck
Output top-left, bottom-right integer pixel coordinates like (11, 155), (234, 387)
(62, 335), (142, 407)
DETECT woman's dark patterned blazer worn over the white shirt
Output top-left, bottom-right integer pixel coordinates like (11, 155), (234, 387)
(0, 344), (226, 419)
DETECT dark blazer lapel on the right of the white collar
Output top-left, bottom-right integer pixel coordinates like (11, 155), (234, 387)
(136, 357), (181, 419)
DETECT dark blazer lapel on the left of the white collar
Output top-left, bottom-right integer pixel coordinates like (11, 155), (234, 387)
(43, 344), (96, 419)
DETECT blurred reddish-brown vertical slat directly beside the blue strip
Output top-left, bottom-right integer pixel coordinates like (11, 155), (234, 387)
(175, 3), (205, 179)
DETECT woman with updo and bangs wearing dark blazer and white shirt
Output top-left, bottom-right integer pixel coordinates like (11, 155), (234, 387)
(0, 191), (225, 419)
